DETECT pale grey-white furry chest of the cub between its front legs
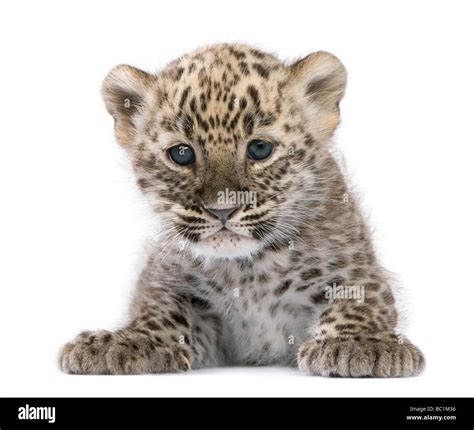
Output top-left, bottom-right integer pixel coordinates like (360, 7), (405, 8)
(191, 269), (323, 364)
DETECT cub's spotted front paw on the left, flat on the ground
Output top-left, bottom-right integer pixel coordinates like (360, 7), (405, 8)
(59, 330), (191, 375)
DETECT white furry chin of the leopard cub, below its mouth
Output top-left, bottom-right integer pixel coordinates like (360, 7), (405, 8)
(191, 231), (262, 260)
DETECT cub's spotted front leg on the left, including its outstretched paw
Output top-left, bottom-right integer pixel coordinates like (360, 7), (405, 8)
(59, 287), (226, 374)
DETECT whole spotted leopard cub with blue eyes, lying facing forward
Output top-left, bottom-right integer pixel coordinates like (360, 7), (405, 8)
(60, 44), (424, 377)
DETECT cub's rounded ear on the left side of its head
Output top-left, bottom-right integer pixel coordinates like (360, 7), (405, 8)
(102, 64), (156, 146)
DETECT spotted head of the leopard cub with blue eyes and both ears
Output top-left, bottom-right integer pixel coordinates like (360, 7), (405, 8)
(102, 44), (346, 258)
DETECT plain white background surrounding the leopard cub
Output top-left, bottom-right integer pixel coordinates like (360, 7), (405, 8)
(0, 0), (474, 396)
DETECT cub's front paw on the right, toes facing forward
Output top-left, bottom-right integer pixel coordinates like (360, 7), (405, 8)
(298, 334), (425, 378)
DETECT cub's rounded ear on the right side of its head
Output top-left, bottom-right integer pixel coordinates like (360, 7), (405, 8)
(290, 51), (347, 140)
